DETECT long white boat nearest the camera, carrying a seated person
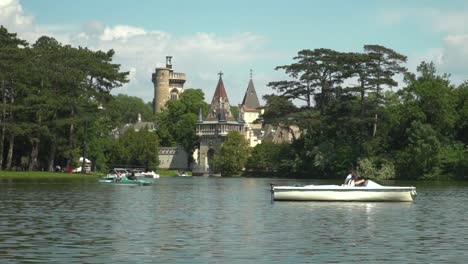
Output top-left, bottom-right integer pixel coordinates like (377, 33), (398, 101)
(271, 180), (416, 202)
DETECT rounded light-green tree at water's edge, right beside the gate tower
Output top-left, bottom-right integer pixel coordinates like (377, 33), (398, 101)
(214, 131), (250, 176)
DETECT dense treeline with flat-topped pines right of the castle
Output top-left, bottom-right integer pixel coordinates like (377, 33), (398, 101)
(247, 45), (468, 179)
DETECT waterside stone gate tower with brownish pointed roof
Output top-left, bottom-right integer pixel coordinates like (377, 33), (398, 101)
(193, 73), (244, 175)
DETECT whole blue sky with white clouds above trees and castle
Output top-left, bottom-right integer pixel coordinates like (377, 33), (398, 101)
(0, 0), (468, 105)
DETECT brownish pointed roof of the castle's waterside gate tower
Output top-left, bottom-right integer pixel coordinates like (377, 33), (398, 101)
(206, 73), (235, 121)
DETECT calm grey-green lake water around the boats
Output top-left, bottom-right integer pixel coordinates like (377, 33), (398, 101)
(0, 177), (468, 263)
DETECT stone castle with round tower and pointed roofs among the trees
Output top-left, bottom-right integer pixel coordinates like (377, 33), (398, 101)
(152, 56), (262, 175)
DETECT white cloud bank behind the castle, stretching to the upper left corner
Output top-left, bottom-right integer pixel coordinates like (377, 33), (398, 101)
(0, 0), (277, 104)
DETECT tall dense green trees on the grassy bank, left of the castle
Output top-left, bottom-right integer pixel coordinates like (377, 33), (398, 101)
(0, 26), (136, 171)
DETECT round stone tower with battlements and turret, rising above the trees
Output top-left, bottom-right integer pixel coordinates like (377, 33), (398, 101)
(152, 56), (187, 113)
